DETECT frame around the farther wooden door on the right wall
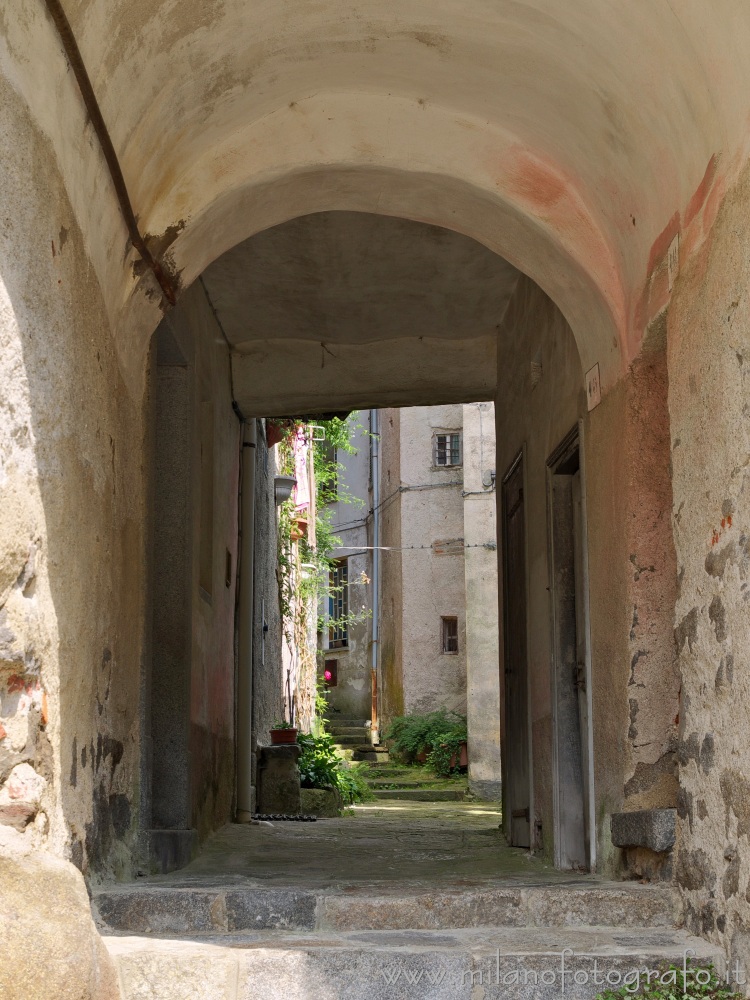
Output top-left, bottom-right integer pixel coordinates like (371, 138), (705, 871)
(498, 450), (539, 851)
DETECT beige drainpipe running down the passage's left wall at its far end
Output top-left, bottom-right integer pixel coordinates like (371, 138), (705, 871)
(237, 419), (258, 823)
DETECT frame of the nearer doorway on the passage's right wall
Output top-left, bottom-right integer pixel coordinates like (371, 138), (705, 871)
(547, 420), (597, 872)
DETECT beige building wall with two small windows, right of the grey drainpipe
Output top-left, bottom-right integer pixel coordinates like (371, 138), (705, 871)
(380, 406), (466, 717)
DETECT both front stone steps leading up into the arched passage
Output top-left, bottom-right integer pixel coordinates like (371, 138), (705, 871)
(100, 883), (719, 1000)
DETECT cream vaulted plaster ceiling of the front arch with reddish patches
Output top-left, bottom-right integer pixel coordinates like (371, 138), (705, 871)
(5, 0), (750, 402)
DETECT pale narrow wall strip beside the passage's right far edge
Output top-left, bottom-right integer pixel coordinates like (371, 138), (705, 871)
(462, 403), (500, 800)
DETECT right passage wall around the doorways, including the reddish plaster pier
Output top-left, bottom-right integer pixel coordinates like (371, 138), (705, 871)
(496, 279), (679, 872)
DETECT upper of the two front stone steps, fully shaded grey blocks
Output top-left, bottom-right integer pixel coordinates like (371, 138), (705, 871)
(92, 881), (681, 936)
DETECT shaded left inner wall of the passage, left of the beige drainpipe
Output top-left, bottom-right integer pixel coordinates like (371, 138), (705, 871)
(144, 282), (240, 856)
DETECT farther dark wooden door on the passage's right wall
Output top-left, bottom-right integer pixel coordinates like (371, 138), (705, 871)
(503, 456), (531, 847)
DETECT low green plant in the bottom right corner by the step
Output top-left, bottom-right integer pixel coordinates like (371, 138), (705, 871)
(596, 957), (744, 1000)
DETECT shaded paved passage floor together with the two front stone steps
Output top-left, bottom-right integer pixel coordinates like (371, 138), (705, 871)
(100, 800), (717, 1000)
